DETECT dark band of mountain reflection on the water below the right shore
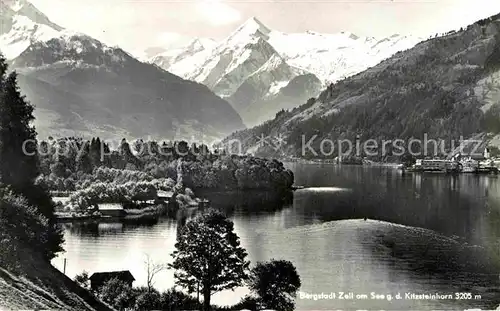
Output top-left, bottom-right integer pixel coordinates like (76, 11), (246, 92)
(288, 165), (500, 244)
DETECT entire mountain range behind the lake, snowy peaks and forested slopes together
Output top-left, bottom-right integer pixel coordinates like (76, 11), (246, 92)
(0, 0), (500, 156)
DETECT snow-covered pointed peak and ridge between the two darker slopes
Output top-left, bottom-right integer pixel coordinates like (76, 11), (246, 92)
(149, 17), (422, 126)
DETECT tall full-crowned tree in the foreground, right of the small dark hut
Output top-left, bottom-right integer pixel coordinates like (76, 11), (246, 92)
(169, 210), (250, 310)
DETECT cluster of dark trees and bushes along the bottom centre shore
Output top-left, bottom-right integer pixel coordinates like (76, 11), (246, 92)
(88, 209), (301, 311)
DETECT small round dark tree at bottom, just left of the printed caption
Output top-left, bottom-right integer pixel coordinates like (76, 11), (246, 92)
(248, 259), (301, 311)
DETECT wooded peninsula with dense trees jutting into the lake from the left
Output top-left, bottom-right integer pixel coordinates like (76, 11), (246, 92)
(35, 137), (294, 219)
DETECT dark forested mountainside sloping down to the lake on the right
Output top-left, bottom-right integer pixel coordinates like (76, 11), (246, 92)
(225, 14), (500, 160)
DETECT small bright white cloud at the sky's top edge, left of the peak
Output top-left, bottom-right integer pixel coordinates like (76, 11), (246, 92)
(196, 0), (241, 26)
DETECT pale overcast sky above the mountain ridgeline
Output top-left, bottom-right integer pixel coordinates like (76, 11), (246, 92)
(32, 0), (500, 51)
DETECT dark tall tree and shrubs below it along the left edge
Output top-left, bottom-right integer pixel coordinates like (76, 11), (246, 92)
(0, 54), (63, 267)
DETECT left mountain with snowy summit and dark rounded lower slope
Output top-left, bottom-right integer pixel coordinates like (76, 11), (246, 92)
(0, 0), (244, 139)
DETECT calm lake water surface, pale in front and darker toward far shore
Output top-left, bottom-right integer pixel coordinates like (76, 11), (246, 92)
(53, 164), (500, 310)
